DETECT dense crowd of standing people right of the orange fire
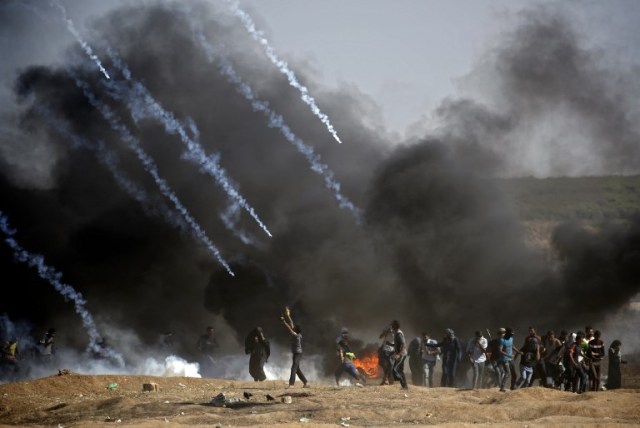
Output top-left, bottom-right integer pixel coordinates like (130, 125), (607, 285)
(400, 326), (626, 394)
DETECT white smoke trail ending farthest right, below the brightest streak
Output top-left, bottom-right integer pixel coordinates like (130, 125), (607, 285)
(192, 25), (363, 223)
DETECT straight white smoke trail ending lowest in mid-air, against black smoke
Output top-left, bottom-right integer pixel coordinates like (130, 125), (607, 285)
(74, 78), (235, 276)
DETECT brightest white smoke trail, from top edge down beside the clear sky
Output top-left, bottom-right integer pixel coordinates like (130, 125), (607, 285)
(227, 0), (342, 144)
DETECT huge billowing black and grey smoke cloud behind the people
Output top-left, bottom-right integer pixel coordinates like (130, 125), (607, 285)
(0, 1), (640, 378)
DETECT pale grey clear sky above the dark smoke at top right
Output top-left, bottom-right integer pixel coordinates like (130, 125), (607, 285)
(241, 0), (640, 137)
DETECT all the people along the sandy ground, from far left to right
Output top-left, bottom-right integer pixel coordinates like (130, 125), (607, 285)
(0, 308), (626, 394)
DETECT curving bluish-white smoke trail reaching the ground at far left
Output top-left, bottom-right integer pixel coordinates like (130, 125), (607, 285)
(0, 210), (124, 366)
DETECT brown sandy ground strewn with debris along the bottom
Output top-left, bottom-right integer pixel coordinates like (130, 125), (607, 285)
(0, 367), (640, 427)
